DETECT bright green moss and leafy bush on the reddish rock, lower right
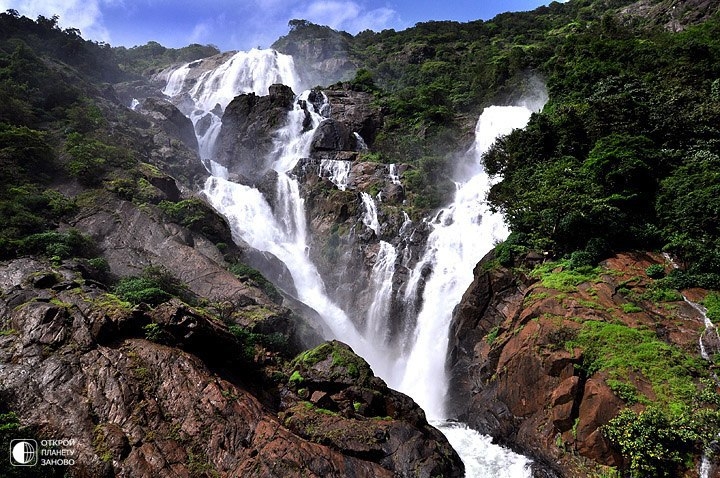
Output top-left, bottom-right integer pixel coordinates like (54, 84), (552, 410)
(565, 321), (720, 478)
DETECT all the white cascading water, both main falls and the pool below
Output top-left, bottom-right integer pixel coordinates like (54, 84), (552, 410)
(164, 50), (530, 477)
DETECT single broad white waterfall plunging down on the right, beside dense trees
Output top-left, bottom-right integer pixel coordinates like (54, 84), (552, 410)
(393, 106), (531, 419)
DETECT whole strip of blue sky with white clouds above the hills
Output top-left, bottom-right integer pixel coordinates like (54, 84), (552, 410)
(0, 0), (564, 51)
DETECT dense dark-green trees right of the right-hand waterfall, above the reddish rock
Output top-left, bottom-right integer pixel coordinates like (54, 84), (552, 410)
(485, 14), (720, 284)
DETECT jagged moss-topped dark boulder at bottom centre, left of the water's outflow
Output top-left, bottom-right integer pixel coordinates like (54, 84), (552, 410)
(281, 341), (464, 478)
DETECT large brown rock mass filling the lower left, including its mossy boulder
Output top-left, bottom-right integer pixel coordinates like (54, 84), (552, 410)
(0, 259), (462, 478)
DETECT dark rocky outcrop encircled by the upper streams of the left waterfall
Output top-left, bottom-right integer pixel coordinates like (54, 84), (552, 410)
(216, 85), (295, 184)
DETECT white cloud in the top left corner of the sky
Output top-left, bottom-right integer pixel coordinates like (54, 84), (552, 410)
(0, 0), (109, 41)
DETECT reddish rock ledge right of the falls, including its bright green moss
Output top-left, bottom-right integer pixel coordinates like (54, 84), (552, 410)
(448, 253), (718, 477)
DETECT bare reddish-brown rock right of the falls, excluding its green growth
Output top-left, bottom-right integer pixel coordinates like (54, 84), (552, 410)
(448, 253), (704, 476)
